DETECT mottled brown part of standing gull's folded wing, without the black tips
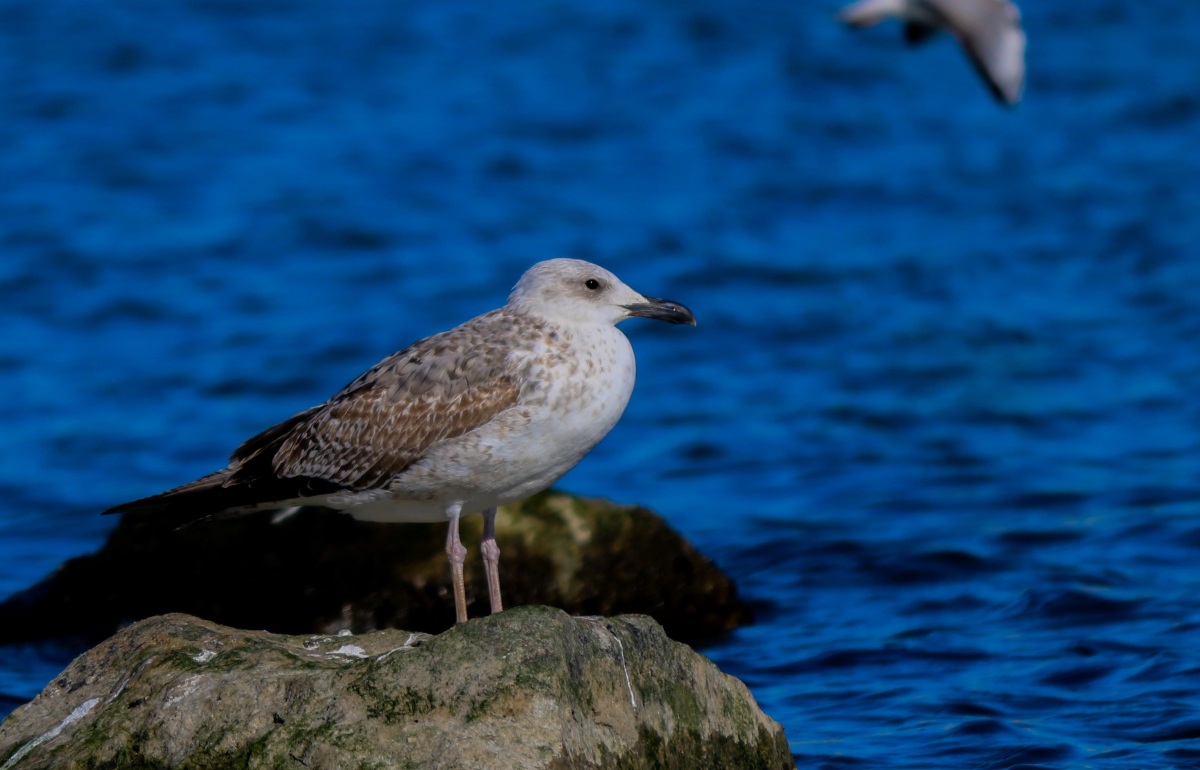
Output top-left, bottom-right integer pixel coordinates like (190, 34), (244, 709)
(262, 313), (520, 489)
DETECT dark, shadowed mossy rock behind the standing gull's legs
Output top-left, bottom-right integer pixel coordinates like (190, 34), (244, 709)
(0, 492), (750, 649)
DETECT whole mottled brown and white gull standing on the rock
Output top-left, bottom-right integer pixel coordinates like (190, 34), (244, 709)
(104, 259), (696, 622)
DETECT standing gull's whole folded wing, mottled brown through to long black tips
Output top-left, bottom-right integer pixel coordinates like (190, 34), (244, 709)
(106, 311), (535, 517)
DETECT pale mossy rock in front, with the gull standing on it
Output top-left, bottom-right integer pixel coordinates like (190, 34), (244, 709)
(0, 607), (793, 770)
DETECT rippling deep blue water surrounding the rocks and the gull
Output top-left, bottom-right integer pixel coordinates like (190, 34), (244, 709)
(0, 0), (1200, 769)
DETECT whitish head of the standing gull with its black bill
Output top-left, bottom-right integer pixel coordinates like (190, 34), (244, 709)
(508, 259), (696, 326)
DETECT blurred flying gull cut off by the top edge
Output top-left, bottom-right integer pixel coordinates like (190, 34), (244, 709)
(839, 0), (1025, 106)
